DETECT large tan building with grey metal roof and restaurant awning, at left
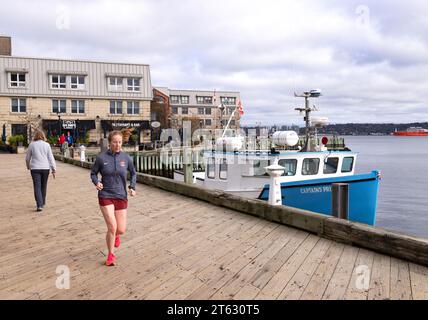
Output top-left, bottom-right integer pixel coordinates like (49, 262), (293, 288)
(0, 37), (153, 143)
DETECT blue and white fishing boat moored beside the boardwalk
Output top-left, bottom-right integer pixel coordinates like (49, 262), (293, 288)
(174, 90), (380, 225)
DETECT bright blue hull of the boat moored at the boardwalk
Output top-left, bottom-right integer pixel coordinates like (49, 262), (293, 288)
(259, 171), (380, 226)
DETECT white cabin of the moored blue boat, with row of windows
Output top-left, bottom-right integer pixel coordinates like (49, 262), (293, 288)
(187, 151), (357, 197)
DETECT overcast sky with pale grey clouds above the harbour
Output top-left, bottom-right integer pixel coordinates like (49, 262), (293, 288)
(0, 0), (428, 125)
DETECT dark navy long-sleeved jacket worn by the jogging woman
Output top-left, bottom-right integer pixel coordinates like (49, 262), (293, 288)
(91, 150), (137, 199)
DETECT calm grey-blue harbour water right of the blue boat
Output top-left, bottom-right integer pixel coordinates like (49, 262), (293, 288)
(345, 136), (428, 238)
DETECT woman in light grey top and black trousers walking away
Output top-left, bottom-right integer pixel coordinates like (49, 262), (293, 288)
(25, 130), (56, 211)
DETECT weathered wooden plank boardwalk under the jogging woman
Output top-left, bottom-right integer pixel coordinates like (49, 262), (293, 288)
(0, 154), (428, 299)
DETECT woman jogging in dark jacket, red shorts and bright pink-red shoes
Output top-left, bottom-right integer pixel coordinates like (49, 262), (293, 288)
(91, 131), (137, 266)
